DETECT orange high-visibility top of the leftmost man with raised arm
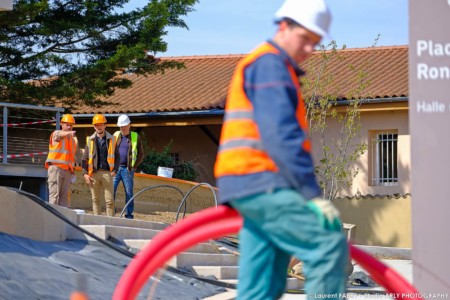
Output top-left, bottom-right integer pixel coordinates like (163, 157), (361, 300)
(45, 132), (77, 171)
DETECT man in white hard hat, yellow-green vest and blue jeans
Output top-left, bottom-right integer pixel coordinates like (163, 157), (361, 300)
(114, 115), (144, 219)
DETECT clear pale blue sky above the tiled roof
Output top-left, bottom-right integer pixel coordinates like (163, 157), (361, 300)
(153, 0), (408, 57)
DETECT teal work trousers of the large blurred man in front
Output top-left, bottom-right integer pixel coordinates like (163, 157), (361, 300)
(230, 189), (349, 300)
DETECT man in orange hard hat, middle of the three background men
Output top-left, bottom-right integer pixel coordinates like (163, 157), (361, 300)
(81, 114), (119, 217)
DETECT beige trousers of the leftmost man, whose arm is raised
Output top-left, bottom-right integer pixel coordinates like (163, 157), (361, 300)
(47, 165), (72, 207)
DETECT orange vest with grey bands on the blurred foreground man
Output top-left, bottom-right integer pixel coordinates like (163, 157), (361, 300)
(214, 43), (311, 178)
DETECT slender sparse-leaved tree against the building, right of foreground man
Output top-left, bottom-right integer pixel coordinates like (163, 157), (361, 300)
(302, 36), (379, 200)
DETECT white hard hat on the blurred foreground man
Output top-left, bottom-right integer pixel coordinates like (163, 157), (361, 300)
(275, 0), (331, 37)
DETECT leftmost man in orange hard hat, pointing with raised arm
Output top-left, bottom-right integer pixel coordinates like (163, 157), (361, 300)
(45, 114), (78, 207)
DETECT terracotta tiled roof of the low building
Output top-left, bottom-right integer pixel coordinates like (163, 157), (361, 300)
(75, 46), (408, 113)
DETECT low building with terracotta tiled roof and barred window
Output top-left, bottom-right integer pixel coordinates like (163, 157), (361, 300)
(75, 46), (410, 195)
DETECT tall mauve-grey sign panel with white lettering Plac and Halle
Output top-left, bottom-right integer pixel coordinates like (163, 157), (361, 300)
(409, 0), (450, 292)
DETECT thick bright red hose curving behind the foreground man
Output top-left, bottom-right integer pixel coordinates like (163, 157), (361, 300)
(113, 206), (421, 300)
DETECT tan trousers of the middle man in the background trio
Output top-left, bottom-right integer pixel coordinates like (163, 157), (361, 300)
(91, 171), (114, 217)
